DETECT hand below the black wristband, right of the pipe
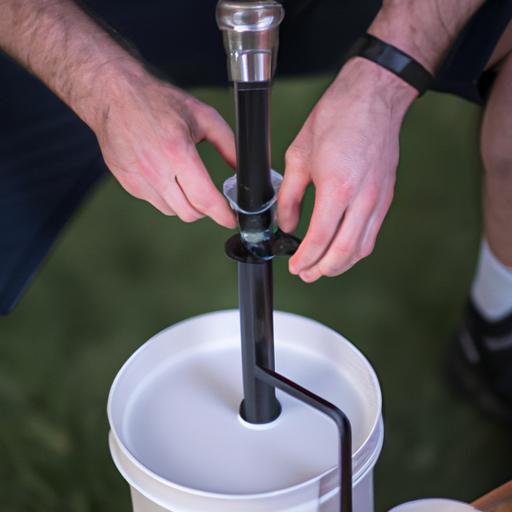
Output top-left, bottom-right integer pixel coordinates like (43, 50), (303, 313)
(278, 58), (417, 282)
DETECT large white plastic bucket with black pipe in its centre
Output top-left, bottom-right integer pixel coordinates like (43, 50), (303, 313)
(108, 311), (383, 512)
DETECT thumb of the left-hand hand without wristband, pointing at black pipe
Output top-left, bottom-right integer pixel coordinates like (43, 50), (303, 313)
(194, 104), (236, 169)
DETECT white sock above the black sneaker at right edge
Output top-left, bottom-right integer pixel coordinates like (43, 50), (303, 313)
(471, 239), (512, 322)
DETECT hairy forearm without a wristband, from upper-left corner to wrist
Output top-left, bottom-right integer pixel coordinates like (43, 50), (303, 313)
(0, 0), (142, 126)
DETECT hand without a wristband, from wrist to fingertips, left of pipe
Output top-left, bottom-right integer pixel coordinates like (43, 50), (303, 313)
(92, 67), (236, 228)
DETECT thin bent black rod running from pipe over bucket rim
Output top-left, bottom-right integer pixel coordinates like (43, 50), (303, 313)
(255, 365), (352, 512)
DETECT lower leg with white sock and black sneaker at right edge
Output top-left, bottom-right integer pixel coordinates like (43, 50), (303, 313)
(449, 27), (512, 424)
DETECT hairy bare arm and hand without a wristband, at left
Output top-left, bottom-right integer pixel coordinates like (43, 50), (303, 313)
(0, 0), (236, 228)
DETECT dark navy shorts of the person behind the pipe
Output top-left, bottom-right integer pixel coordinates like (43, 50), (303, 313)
(0, 0), (512, 314)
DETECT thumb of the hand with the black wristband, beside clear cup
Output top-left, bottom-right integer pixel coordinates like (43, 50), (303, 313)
(277, 167), (310, 233)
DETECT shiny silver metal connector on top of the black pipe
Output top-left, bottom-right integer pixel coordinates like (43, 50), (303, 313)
(216, 0), (284, 82)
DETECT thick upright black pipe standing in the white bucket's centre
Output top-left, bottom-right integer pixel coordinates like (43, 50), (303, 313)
(235, 82), (281, 423)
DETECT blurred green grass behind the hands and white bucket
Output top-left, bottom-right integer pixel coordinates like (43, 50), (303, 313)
(0, 79), (512, 512)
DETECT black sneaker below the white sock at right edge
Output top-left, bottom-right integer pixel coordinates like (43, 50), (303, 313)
(447, 301), (512, 424)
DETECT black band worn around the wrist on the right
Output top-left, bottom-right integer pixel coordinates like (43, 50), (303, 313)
(347, 34), (434, 96)
